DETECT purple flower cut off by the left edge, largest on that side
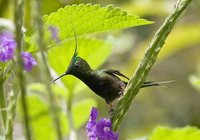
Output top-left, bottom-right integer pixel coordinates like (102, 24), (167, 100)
(0, 32), (17, 62)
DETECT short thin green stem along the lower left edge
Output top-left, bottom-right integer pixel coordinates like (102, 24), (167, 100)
(0, 68), (7, 132)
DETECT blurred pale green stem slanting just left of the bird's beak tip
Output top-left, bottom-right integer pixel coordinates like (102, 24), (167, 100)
(34, 0), (62, 140)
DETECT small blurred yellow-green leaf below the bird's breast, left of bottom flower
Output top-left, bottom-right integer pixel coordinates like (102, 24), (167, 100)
(73, 98), (97, 129)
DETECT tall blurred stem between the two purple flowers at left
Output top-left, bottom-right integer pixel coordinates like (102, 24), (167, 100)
(14, 0), (31, 140)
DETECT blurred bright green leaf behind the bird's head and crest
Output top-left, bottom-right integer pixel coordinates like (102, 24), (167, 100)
(48, 38), (111, 91)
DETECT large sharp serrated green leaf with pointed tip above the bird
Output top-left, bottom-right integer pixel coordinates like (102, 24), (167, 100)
(44, 4), (153, 39)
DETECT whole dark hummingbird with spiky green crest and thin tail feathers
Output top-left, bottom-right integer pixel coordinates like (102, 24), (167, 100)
(53, 32), (170, 111)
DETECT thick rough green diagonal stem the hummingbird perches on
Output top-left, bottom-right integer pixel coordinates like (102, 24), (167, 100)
(111, 0), (192, 131)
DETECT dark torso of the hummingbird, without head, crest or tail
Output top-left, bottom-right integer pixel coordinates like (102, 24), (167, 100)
(72, 69), (126, 104)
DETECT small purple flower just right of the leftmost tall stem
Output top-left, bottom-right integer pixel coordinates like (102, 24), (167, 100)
(21, 52), (37, 71)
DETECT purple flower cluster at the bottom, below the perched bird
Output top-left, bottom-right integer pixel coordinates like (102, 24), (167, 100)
(86, 107), (118, 140)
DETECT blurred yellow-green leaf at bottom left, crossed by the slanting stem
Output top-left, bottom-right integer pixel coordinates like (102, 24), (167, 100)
(19, 94), (69, 140)
